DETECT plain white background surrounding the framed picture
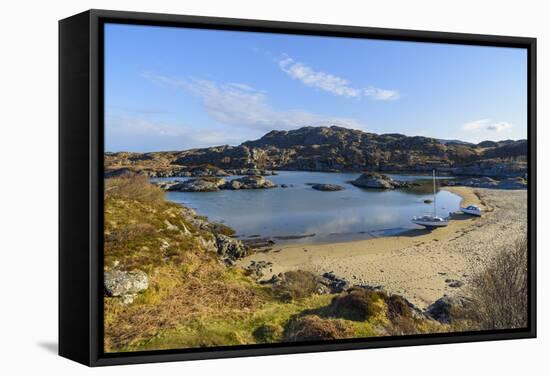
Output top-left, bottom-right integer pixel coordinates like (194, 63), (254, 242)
(0, 0), (550, 376)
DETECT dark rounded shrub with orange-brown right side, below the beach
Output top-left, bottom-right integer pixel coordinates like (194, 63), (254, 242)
(329, 288), (387, 321)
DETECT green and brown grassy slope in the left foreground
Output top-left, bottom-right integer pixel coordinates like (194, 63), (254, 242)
(104, 177), (449, 352)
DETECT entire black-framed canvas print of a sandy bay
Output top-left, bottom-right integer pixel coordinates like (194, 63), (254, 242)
(59, 10), (536, 366)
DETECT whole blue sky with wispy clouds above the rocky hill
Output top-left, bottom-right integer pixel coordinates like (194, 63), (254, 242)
(105, 24), (527, 151)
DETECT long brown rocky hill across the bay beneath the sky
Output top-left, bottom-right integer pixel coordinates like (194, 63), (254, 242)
(105, 126), (527, 177)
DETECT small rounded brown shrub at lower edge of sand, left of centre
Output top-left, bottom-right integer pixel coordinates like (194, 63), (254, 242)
(273, 270), (321, 301)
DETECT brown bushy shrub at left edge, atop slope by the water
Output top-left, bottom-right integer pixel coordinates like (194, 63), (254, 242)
(105, 174), (164, 204)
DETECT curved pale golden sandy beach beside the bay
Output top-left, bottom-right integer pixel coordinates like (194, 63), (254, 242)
(239, 187), (527, 309)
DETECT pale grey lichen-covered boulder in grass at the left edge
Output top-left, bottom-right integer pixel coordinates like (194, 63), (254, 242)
(103, 270), (149, 304)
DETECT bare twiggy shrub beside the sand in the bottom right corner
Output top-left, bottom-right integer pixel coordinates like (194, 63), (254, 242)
(464, 237), (528, 329)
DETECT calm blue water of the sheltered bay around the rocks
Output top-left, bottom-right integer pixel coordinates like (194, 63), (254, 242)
(156, 171), (460, 243)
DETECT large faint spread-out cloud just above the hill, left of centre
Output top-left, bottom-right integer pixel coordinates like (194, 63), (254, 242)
(143, 74), (364, 131)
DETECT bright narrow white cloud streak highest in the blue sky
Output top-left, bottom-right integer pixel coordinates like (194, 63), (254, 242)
(278, 54), (399, 101)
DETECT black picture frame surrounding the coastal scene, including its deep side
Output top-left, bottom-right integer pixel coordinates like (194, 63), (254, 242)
(59, 10), (537, 366)
